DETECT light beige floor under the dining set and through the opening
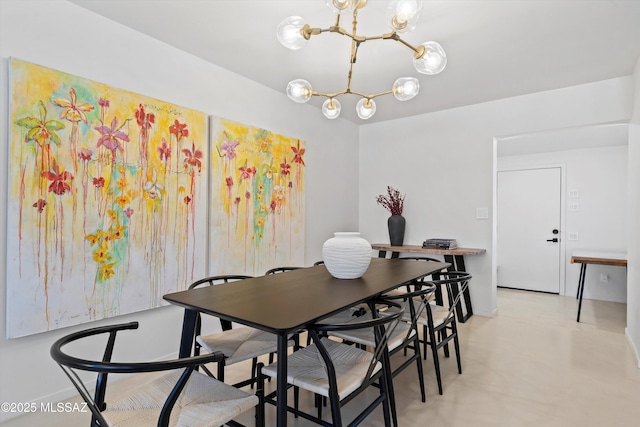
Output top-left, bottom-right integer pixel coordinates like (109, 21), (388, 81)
(5, 289), (640, 427)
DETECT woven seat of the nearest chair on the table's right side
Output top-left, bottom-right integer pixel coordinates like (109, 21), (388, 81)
(262, 338), (382, 399)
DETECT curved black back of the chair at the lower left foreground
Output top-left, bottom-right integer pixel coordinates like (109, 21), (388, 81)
(50, 322), (224, 427)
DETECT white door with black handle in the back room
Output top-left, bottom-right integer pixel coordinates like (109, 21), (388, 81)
(497, 167), (562, 293)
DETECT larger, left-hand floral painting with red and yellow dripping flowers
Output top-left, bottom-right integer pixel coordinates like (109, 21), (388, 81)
(7, 59), (209, 338)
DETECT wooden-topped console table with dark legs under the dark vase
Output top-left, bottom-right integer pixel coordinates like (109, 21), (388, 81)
(371, 243), (486, 323)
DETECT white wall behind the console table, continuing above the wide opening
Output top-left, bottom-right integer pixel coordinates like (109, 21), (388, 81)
(360, 77), (633, 315)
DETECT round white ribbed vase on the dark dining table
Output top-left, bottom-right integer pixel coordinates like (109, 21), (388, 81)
(322, 232), (371, 279)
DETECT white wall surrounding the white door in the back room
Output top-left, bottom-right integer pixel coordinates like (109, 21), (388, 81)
(498, 147), (628, 302)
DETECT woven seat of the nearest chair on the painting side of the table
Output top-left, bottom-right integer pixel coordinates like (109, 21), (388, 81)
(196, 327), (278, 365)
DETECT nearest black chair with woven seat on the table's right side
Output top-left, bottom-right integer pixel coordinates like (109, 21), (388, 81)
(258, 300), (404, 426)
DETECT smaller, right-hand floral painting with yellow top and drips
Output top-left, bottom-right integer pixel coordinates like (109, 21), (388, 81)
(210, 117), (305, 275)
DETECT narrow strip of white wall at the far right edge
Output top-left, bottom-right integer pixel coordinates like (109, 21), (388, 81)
(627, 58), (640, 368)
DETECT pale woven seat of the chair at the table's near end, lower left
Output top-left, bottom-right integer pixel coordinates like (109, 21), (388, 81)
(102, 370), (258, 427)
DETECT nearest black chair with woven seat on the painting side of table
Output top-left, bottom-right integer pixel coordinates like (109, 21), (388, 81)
(189, 275), (296, 387)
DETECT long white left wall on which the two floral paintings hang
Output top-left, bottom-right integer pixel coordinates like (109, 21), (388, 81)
(0, 0), (358, 422)
